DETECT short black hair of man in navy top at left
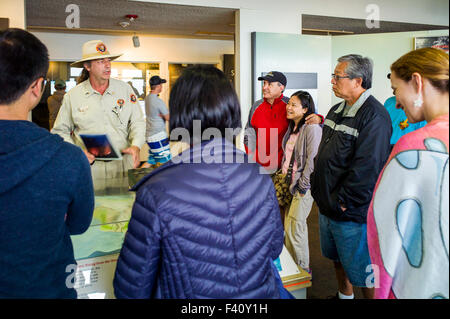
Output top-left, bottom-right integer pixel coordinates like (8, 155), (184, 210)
(0, 28), (49, 104)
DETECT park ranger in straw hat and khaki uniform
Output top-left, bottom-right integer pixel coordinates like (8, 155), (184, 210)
(52, 40), (145, 179)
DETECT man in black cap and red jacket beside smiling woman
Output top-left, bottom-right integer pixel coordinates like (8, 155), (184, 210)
(244, 71), (323, 173)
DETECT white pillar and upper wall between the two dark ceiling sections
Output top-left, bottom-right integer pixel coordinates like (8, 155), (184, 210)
(137, 0), (449, 147)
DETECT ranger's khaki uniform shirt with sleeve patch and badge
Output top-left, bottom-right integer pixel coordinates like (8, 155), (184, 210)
(51, 79), (145, 181)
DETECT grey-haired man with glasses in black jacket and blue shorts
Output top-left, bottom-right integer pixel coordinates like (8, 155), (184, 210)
(311, 54), (392, 299)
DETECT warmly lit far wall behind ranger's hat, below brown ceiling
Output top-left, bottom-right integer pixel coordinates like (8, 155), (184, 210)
(33, 32), (234, 103)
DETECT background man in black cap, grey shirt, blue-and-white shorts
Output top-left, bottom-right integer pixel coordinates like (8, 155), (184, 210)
(143, 75), (171, 167)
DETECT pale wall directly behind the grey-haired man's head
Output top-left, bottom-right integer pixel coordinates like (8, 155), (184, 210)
(331, 30), (449, 105)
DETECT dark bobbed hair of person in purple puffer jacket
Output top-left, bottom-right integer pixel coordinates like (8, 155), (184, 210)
(169, 65), (241, 141)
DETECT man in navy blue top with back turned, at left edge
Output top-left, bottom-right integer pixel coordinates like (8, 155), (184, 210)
(0, 28), (94, 299)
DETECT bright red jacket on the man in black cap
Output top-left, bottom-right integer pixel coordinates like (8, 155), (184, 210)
(246, 95), (288, 169)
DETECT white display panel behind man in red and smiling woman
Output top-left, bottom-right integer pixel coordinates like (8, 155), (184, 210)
(251, 32), (332, 115)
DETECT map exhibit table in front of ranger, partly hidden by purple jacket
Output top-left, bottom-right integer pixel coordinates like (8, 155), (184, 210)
(71, 175), (311, 299)
